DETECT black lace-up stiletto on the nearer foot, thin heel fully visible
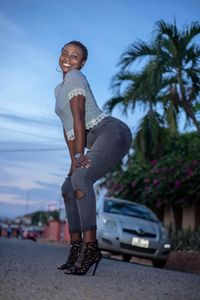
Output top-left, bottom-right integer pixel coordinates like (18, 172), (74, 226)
(64, 241), (102, 275)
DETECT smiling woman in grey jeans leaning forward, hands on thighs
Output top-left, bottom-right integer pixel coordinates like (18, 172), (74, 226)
(55, 41), (132, 275)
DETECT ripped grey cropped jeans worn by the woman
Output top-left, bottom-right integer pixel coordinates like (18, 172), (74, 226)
(62, 116), (132, 233)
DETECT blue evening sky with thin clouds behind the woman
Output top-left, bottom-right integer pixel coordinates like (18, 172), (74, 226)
(0, 0), (200, 218)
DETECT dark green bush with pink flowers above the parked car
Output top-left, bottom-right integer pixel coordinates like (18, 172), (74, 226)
(105, 133), (200, 208)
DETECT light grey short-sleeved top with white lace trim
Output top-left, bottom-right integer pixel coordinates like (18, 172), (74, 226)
(55, 70), (107, 140)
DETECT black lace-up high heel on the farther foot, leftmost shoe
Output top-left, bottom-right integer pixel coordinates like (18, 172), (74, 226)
(58, 241), (83, 272)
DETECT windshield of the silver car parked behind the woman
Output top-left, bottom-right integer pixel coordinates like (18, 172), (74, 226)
(104, 199), (158, 222)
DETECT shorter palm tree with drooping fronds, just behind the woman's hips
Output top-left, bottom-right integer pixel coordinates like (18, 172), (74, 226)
(105, 62), (170, 163)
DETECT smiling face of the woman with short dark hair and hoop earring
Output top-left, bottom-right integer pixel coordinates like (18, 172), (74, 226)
(59, 44), (85, 73)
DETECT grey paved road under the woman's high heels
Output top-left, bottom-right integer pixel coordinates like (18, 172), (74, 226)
(0, 238), (200, 300)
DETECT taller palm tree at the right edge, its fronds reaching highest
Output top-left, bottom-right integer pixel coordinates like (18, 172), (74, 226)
(108, 20), (200, 131)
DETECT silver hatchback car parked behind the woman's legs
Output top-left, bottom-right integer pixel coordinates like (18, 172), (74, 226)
(97, 197), (171, 268)
